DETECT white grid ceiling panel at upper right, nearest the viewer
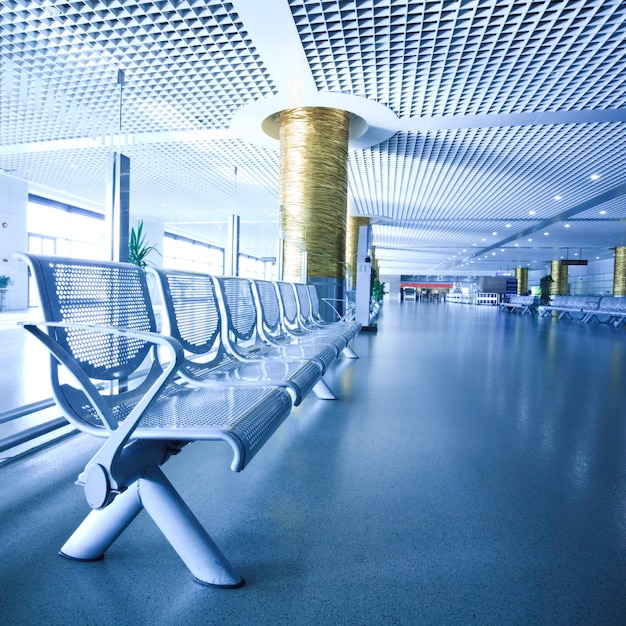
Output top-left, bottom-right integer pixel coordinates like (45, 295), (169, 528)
(289, 0), (626, 117)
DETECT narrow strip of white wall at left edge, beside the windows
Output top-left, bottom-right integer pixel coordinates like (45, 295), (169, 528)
(0, 174), (28, 311)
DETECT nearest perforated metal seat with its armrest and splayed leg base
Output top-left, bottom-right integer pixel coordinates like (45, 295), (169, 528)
(20, 254), (292, 587)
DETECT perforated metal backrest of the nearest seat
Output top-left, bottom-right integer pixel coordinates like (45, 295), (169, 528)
(18, 254), (163, 434)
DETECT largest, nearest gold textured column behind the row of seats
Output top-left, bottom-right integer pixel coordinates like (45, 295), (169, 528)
(280, 107), (350, 280)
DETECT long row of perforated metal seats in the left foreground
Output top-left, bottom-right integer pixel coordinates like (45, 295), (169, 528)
(20, 254), (360, 587)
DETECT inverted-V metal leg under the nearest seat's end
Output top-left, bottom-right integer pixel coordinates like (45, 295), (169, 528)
(60, 467), (244, 589)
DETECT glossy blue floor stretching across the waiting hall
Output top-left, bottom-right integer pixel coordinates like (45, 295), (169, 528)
(0, 302), (626, 625)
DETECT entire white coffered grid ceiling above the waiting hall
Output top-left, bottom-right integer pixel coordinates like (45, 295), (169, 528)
(0, 0), (626, 274)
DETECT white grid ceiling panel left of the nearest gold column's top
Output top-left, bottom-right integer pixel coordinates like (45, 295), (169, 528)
(0, 0), (275, 144)
